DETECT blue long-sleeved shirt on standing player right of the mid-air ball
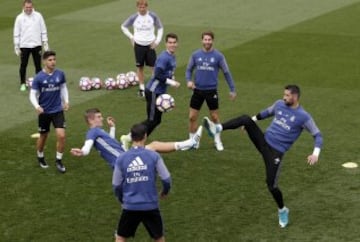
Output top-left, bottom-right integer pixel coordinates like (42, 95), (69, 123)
(185, 49), (235, 92)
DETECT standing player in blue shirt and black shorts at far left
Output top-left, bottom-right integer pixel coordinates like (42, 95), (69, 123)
(30, 51), (69, 173)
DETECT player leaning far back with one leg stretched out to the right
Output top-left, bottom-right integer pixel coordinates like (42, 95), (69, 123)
(70, 108), (202, 169)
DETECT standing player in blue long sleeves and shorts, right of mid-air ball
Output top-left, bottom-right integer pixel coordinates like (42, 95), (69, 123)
(185, 31), (236, 151)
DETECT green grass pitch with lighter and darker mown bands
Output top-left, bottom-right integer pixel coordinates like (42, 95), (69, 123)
(0, 0), (360, 242)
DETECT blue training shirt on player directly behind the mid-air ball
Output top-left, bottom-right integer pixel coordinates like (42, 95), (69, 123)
(146, 50), (176, 94)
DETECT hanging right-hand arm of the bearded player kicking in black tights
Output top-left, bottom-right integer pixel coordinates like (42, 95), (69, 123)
(304, 117), (323, 165)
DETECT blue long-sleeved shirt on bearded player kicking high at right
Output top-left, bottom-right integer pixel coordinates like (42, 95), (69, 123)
(260, 100), (323, 153)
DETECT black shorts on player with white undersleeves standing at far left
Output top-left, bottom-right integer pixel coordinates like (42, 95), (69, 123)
(38, 111), (66, 133)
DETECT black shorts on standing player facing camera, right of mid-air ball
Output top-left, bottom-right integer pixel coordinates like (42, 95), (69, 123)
(190, 89), (219, 110)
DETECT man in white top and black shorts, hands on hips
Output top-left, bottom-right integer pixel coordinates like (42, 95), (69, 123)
(121, 0), (163, 97)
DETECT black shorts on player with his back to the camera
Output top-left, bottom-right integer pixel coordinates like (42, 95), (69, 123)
(117, 209), (164, 240)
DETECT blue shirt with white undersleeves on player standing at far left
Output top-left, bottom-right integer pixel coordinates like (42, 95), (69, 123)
(31, 69), (66, 113)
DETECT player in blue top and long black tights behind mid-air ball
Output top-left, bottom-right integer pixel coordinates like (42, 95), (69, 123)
(121, 33), (180, 147)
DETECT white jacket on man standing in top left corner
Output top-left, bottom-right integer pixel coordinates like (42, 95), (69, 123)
(14, 10), (48, 48)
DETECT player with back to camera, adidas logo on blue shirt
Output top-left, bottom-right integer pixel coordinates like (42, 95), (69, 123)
(112, 124), (171, 242)
